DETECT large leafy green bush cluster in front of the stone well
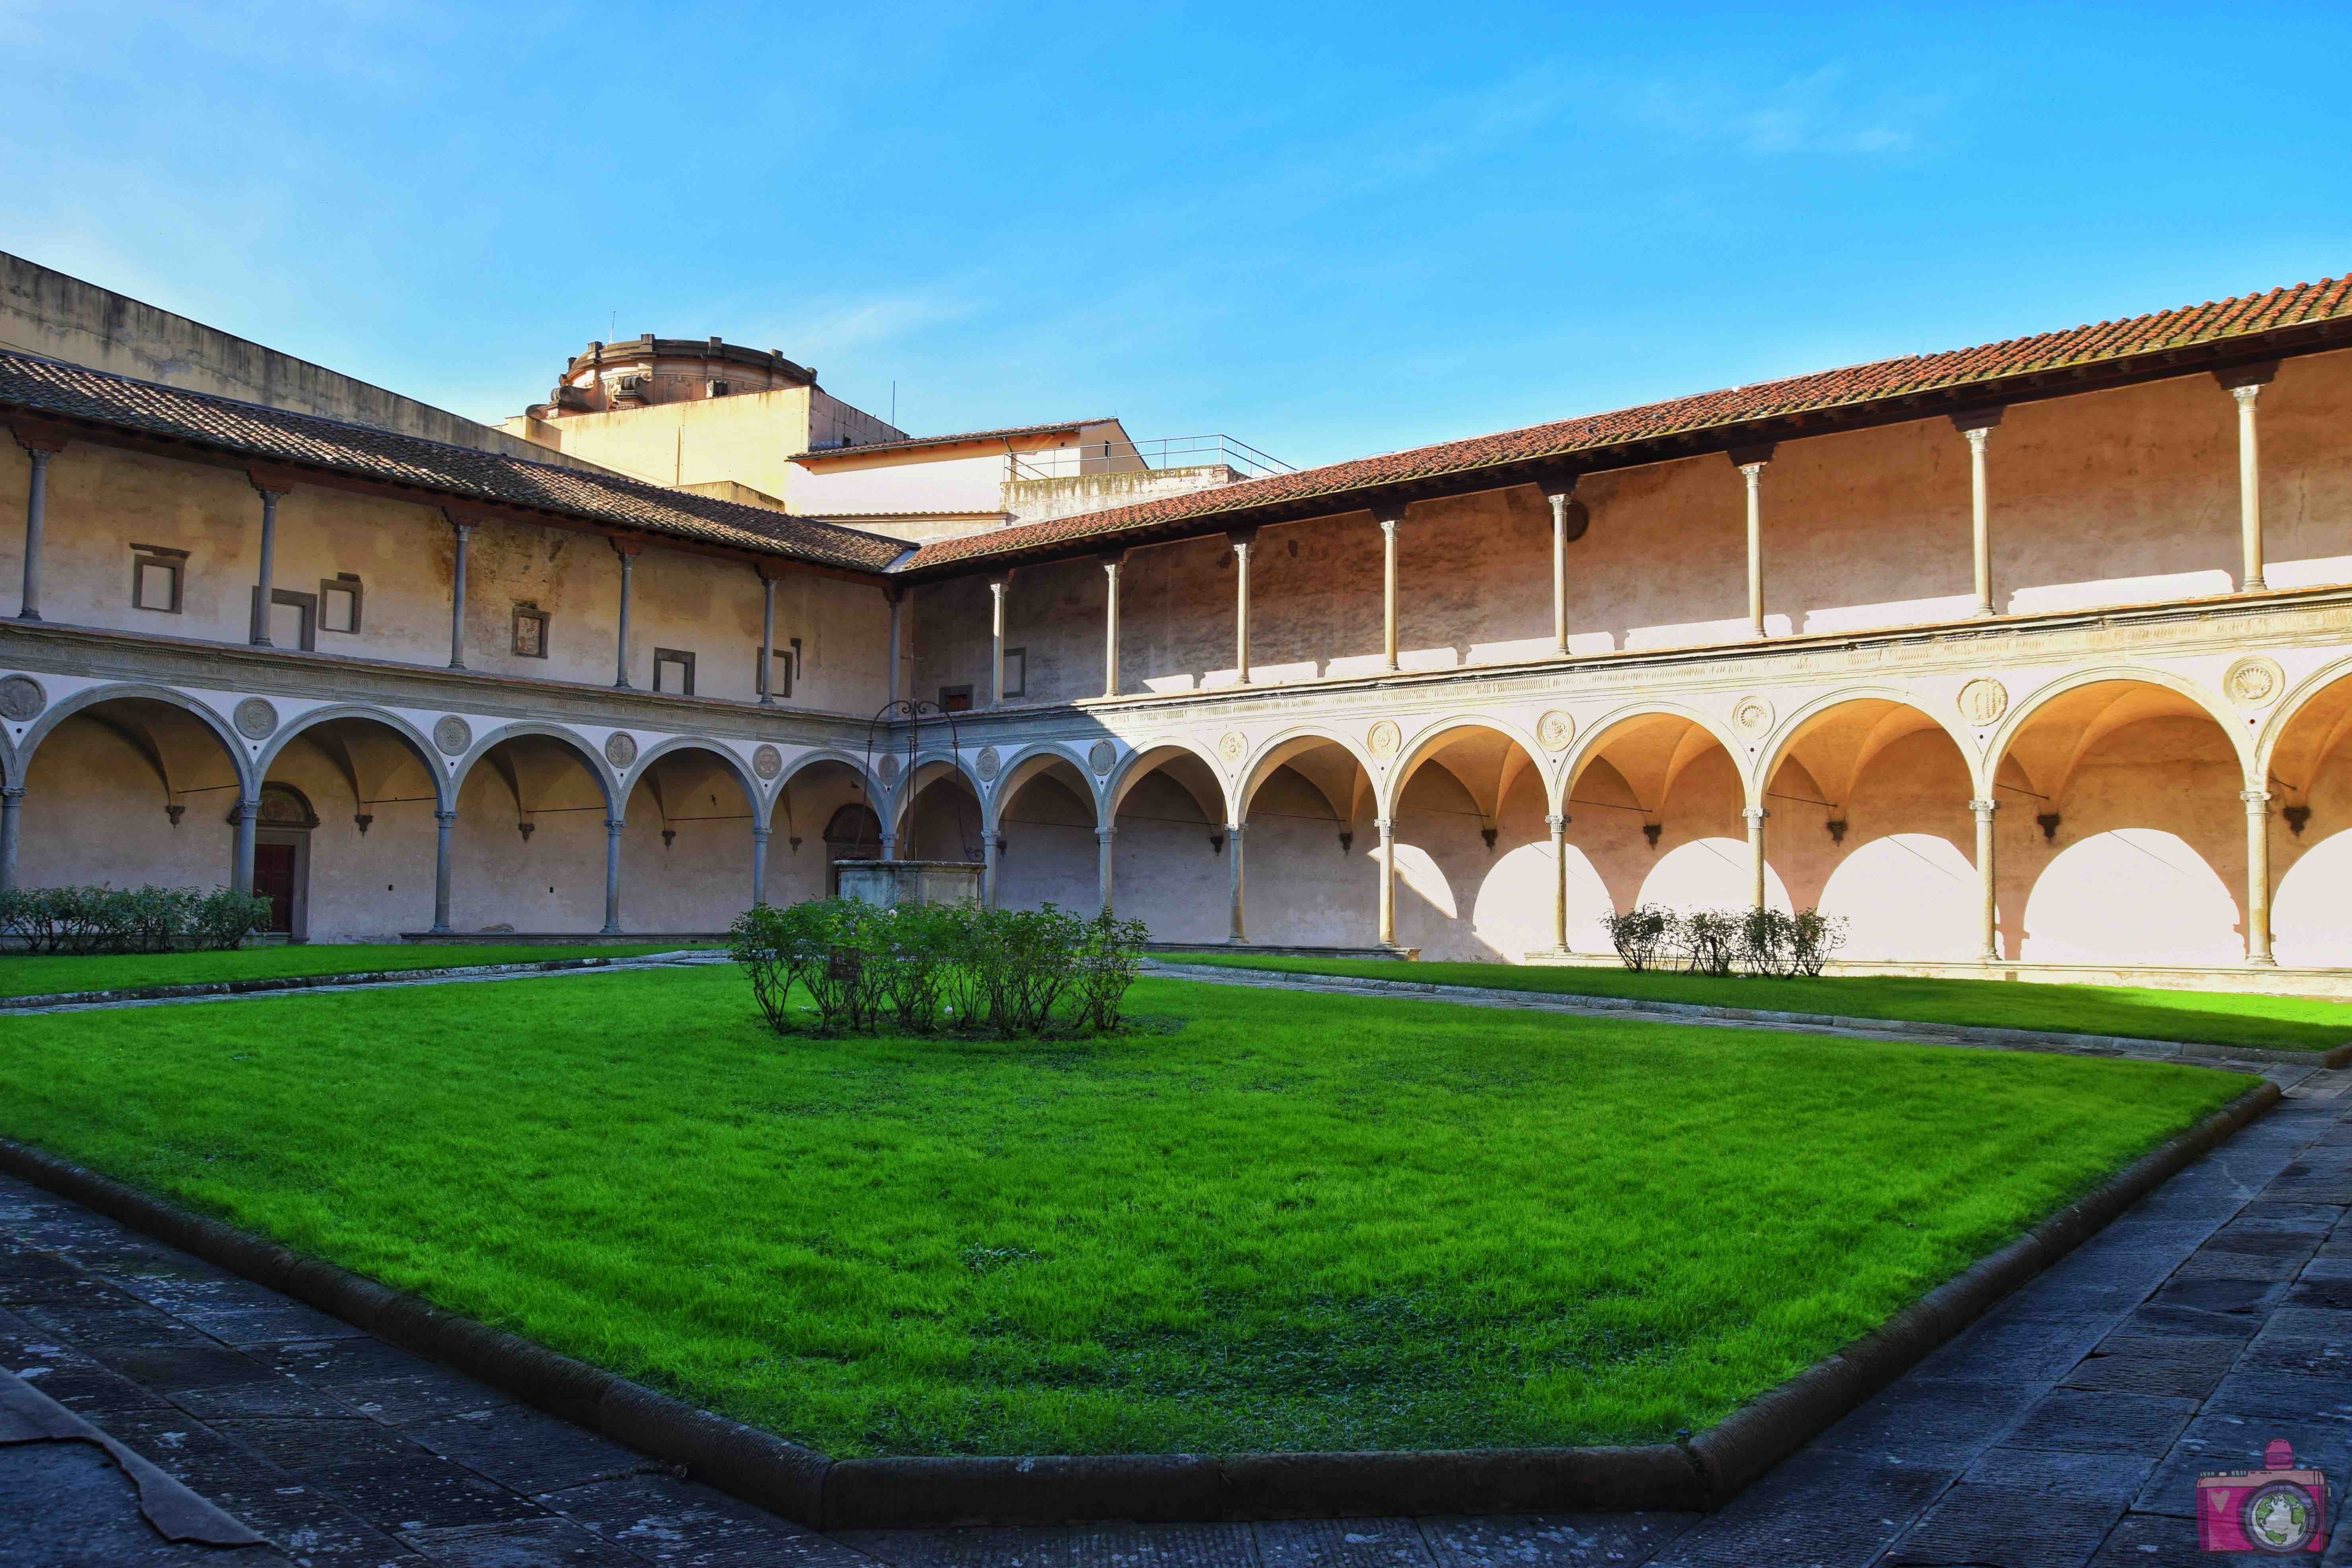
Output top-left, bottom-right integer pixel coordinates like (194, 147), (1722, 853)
(729, 898), (1148, 1034)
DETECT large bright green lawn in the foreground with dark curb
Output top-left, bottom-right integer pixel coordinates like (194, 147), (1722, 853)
(0, 966), (2251, 1455)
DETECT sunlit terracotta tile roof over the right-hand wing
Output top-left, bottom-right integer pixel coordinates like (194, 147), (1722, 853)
(903, 275), (2352, 571)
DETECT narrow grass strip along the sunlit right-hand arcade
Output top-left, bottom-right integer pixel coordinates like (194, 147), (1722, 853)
(1164, 952), (2352, 1051)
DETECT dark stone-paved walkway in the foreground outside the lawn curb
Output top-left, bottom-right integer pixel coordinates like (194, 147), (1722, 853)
(0, 1067), (2352, 1568)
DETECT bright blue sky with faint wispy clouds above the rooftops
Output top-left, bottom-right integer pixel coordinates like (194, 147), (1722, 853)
(0, 0), (2352, 465)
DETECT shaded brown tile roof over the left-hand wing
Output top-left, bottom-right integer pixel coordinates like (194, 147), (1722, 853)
(0, 350), (905, 574)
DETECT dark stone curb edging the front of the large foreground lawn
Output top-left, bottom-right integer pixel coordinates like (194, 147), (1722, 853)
(0, 1079), (2281, 1530)
